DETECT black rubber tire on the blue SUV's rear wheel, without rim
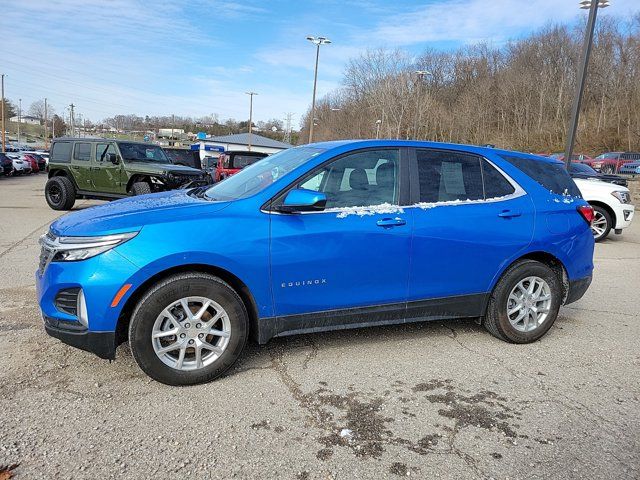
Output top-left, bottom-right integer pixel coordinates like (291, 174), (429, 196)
(484, 260), (564, 343)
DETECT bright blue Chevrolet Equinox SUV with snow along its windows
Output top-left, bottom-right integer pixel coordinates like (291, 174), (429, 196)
(36, 140), (594, 385)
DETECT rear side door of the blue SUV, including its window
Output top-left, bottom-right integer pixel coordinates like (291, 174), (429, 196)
(408, 149), (534, 316)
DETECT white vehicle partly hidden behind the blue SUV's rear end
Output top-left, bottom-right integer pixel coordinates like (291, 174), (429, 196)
(574, 178), (635, 242)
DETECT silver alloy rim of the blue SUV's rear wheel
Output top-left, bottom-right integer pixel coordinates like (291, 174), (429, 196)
(507, 277), (551, 332)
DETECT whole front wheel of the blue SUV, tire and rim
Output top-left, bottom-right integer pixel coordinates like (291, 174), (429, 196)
(129, 272), (249, 385)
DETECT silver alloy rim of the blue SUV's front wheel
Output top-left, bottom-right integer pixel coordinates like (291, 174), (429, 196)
(151, 297), (231, 371)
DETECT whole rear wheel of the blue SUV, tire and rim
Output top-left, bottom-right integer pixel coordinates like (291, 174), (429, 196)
(484, 260), (563, 343)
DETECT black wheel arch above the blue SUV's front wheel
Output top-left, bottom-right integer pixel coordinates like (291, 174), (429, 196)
(115, 263), (258, 347)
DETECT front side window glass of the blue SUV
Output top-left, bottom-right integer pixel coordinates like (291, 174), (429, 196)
(295, 149), (400, 208)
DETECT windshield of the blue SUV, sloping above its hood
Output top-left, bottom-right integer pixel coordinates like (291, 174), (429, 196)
(205, 147), (324, 201)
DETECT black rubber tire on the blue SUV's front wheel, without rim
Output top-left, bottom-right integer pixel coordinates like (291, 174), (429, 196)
(129, 272), (249, 386)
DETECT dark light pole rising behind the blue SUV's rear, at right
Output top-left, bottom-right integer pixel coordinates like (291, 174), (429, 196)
(564, 0), (609, 169)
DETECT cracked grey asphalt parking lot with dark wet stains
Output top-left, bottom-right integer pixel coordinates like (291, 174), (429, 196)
(0, 175), (640, 479)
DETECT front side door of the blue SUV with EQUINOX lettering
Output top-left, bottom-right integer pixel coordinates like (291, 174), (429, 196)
(271, 149), (412, 318)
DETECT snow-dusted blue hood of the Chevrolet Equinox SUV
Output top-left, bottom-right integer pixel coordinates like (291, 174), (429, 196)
(51, 190), (229, 237)
